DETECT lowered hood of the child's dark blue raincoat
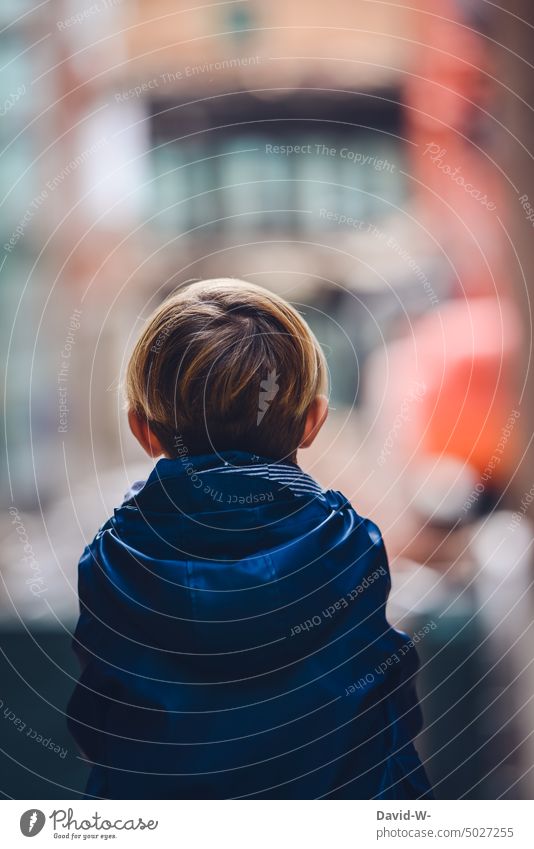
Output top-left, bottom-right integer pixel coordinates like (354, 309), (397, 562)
(80, 452), (379, 675)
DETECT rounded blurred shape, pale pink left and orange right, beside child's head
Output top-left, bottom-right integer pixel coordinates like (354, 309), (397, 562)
(365, 297), (521, 483)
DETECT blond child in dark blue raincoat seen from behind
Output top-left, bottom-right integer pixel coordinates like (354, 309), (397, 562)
(68, 279), (431, 799)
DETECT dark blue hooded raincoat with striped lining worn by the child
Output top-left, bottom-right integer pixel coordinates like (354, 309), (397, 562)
(67, 451), (431, 799)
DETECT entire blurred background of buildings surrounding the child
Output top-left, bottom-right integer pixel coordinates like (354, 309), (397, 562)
(0, 0), (534, 798)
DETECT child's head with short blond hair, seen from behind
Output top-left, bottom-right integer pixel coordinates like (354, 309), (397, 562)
(126, 279), (328, 460)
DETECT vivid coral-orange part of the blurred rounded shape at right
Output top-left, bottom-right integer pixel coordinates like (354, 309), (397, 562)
(414, 298), (521, 480)
